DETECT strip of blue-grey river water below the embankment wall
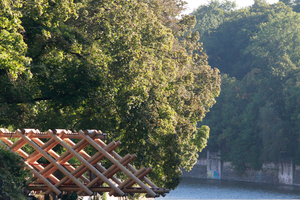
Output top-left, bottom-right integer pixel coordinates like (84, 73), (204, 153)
(156, 178), (300, 200)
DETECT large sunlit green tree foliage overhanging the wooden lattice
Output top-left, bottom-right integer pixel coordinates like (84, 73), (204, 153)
(0, 0), (221, 192)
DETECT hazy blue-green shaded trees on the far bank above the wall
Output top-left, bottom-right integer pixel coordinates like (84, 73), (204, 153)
(193, 0), (300, 172)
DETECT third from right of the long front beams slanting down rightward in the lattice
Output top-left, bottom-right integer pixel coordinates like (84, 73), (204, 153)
(16, 130), (93, 195)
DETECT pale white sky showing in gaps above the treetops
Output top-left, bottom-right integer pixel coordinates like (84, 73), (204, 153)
(184, 0), (279, 14)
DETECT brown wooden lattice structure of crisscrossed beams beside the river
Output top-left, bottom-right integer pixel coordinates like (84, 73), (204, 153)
(0, 128), (169, 197)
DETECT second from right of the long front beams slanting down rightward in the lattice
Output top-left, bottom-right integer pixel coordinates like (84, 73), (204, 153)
(44, 131), (124, 196)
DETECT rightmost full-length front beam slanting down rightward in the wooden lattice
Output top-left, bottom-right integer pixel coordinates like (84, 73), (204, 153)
(78, 131), (155, 197)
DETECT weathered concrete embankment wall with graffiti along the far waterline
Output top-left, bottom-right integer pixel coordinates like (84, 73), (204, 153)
(183, 151), (300, 185)
